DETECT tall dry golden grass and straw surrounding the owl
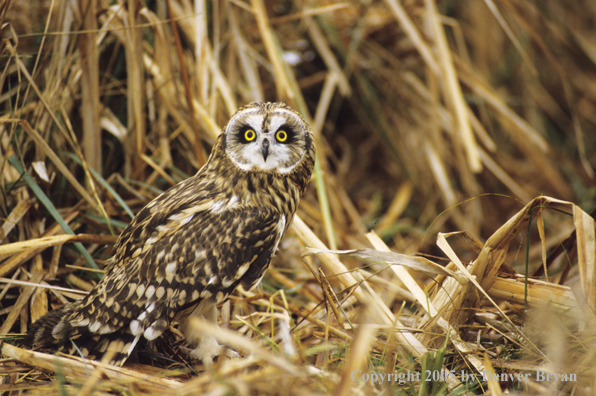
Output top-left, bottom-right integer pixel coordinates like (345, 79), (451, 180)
(0, 0), (596, 395)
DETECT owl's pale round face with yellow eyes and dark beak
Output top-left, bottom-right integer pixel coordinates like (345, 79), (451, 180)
(224, 102), (312, 174)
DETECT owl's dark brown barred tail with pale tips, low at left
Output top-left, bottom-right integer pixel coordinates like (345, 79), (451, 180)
(23, 302), (141, 366)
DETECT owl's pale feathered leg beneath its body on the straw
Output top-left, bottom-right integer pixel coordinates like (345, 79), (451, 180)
(179, 300), (238, 366)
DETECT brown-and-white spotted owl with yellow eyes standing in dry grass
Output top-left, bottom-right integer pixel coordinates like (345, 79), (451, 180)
(24, 102), (315, 365)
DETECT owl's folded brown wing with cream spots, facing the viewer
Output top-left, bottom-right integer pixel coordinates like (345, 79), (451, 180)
(64, 204), (286, 340)
